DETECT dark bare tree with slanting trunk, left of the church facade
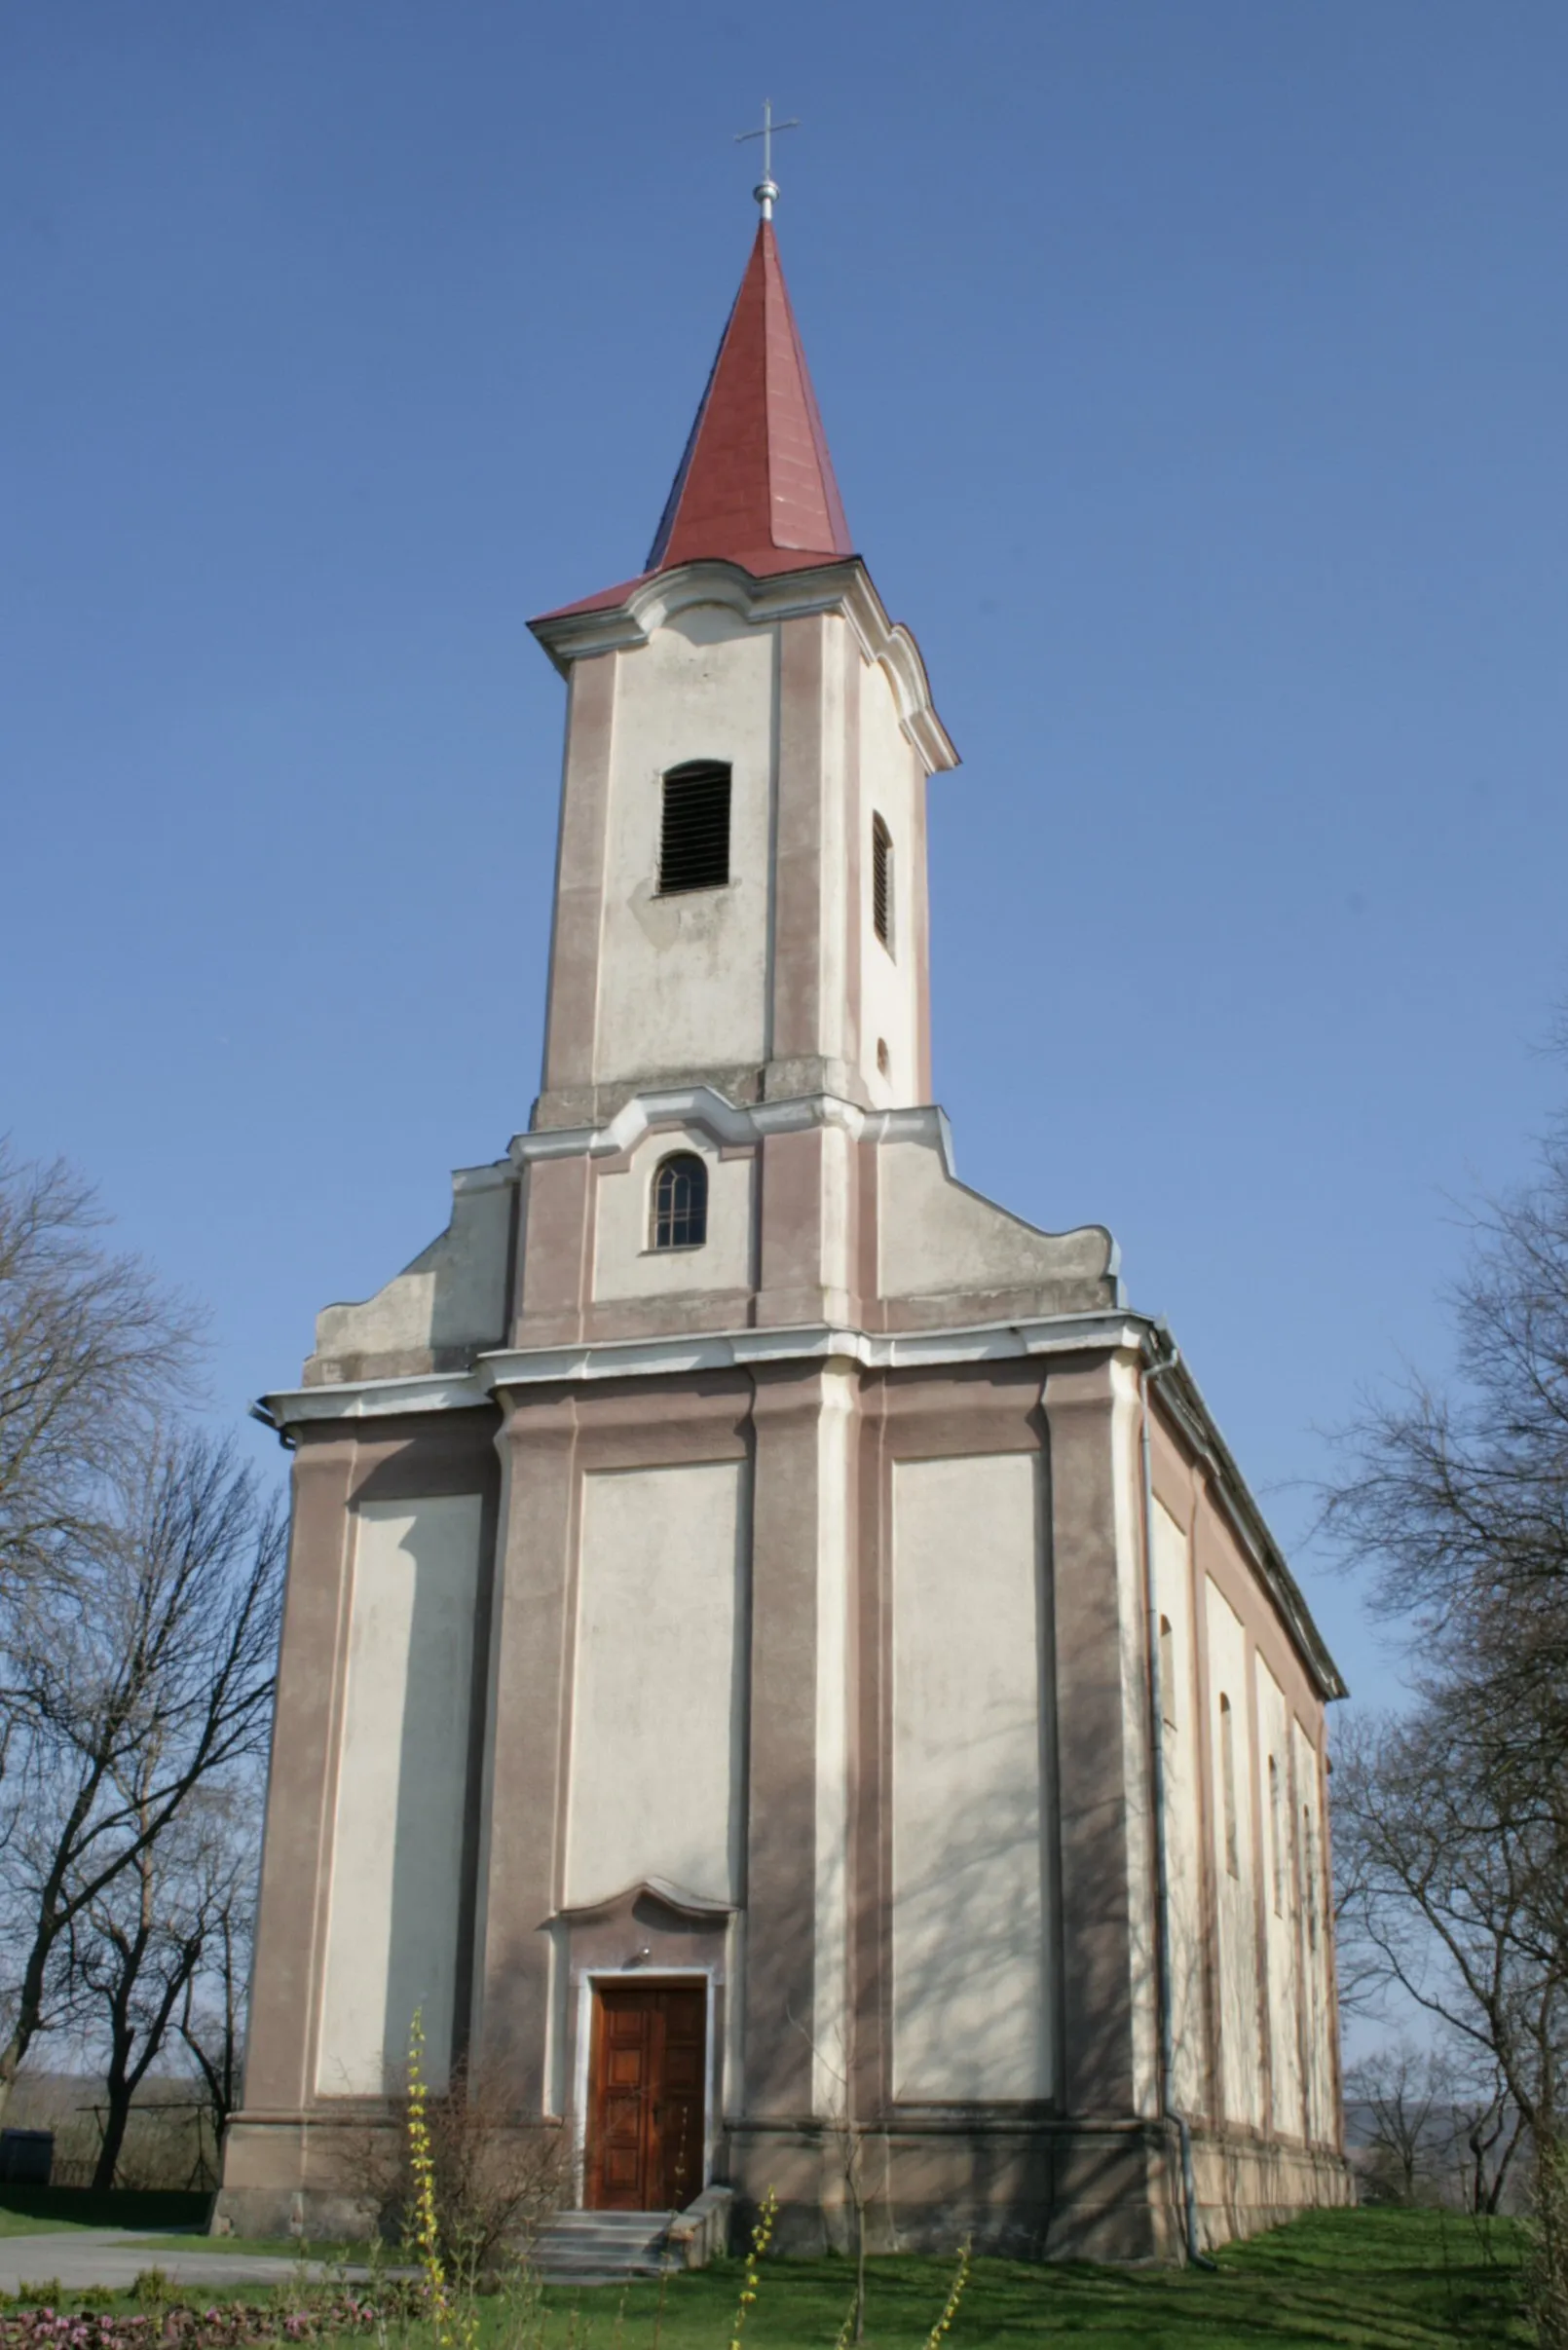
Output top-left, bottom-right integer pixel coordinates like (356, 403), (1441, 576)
(0, 1434), (284, 2110)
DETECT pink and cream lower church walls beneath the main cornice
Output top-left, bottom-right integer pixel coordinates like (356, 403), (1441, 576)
(226, 1354), (1340, 2256)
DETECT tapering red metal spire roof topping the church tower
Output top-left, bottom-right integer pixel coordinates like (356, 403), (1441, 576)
(647, 221), (853, 576)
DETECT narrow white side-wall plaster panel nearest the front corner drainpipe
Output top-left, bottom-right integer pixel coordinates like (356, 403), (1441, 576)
(1154, 1502), (1209, 2115)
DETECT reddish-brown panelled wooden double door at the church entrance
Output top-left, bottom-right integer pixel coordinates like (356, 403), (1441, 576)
(583, 1984), (708, 2212)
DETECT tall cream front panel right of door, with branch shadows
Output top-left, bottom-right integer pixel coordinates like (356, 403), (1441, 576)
(893, 1452), (1056, 2104)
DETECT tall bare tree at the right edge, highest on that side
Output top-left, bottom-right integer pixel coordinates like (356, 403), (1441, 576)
(1325, 1090), (1568, 2343)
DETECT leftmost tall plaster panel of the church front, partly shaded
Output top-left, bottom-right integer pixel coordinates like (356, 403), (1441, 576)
(317, 1495), (479, 2096)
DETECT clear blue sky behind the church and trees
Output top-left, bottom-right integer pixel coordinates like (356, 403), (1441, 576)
(0, 0), (1568, 1720)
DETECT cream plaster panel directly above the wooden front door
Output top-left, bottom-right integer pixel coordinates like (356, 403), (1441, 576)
(567, 1462), (745, 1908)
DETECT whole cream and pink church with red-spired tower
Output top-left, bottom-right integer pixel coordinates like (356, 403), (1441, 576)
(218, 174), (1350, 2260)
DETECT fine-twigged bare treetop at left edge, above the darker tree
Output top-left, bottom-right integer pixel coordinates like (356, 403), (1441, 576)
(0, 1142), (198, 1605)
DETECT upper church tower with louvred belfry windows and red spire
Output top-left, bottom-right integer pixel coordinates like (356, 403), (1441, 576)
(534, 221), (954, 1126)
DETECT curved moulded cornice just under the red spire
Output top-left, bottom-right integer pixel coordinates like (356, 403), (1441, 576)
(529, 554), (959, 773)
